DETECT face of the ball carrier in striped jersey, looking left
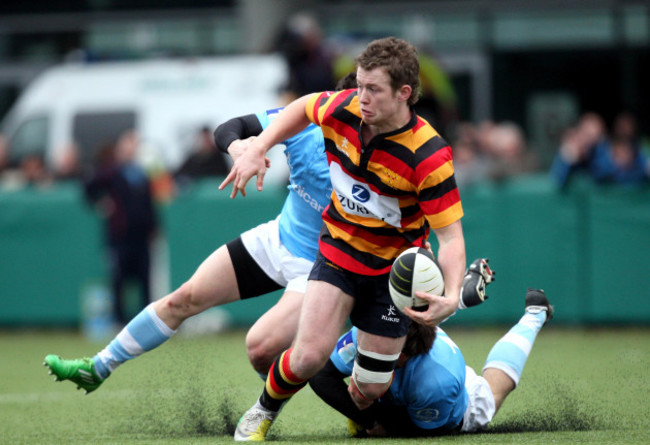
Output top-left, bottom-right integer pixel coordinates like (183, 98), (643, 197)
(357, 68), (402, 127)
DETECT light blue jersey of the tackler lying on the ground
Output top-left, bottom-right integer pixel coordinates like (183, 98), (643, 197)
(330, 328), (467, 430)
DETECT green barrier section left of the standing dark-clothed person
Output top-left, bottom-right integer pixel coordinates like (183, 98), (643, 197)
(0, 184), (103, 326)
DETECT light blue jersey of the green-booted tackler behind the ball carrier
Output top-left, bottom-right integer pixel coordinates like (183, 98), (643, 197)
(256, 108), (332, 261)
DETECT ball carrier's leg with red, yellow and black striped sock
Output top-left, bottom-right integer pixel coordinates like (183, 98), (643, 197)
(234, 281), (354, 441)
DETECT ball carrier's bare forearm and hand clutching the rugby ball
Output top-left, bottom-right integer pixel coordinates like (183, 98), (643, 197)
(404, 221), (466, 326)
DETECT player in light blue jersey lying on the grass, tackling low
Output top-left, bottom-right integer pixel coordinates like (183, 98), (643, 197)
(310, 289), (553, 437)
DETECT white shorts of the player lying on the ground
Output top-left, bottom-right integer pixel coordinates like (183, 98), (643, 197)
(460, 366), (496, 433)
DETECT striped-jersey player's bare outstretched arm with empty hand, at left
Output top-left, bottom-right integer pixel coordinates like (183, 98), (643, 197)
(219, 95), (316, 198)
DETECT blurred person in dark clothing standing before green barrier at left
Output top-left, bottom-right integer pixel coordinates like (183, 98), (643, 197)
(84, 130), (157, 325)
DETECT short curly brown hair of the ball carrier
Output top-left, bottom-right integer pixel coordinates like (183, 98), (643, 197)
(354, 37), (420, 106)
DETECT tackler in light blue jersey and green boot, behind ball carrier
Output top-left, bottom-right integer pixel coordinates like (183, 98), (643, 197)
(40, 74), (346, 393)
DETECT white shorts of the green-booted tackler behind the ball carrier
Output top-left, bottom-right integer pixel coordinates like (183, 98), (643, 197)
(241, 216), (314, 293)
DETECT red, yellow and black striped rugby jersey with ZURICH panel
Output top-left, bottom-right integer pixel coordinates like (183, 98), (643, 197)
(306, 89), (463, 275)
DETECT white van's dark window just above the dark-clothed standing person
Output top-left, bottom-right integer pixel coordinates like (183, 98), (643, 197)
(72, 110), (136, 165)
